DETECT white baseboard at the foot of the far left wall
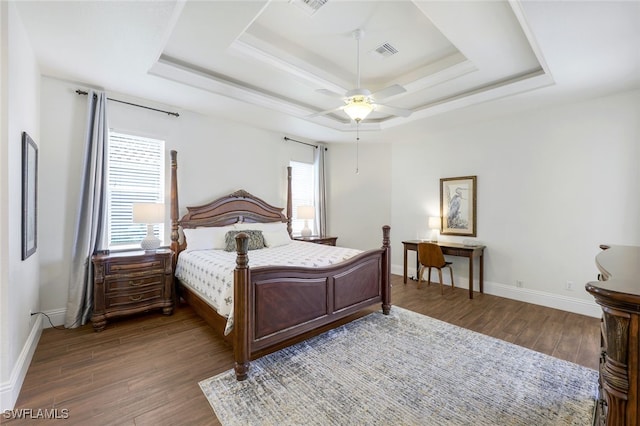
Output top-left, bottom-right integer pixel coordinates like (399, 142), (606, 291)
(0, 315), (42, 412)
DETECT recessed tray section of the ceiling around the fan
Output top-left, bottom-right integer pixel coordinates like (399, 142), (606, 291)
(150, 1), (552, 129)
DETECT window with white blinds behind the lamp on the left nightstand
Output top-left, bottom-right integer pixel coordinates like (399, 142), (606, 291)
(106, 132), (164, 249)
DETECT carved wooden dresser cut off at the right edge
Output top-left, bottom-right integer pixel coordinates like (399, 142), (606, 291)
(586, 246), (640, 426)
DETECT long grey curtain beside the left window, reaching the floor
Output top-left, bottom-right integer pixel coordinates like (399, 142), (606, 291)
(64, 90), (109, 328)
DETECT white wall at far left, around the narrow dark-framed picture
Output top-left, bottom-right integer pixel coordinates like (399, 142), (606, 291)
(0, 2), (41, 410)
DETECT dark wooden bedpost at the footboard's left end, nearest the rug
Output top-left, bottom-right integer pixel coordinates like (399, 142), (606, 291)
(233, 232), (252, 380)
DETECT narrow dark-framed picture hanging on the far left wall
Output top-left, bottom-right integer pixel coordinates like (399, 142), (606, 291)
(22, 132), (38, 260)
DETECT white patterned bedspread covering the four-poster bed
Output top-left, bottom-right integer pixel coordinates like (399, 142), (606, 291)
(175, 241), (362, 334)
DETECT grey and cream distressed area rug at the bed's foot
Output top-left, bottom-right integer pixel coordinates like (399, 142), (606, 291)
(200, 307), (598, 426)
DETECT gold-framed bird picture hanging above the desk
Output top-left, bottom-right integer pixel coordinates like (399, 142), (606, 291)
(440, 176), (478, 237)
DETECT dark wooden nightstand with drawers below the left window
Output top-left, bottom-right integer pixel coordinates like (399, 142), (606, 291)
(91, 249), (174, 331)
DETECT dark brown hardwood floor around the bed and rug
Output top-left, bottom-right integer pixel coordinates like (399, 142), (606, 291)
(6, 276), (600, 425)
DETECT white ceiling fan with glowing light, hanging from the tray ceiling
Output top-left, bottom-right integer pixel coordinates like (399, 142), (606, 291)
(309, 29), (411, 124)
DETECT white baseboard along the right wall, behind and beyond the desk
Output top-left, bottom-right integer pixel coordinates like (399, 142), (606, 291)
(391, 265), (602, 318)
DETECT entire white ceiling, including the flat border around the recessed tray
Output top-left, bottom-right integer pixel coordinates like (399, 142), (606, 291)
(16, 0), (640, 142)
